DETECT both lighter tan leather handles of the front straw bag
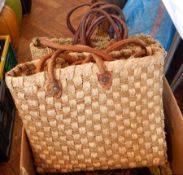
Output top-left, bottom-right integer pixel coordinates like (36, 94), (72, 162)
(36, 38), (151, 97)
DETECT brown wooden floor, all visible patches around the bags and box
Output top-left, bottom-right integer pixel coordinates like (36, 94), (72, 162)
(0, 0), (183, 175)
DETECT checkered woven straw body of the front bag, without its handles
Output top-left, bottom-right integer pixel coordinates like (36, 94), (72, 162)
(6, 35), (167, 173)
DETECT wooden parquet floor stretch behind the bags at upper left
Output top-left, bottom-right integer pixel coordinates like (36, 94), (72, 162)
(18, 0), (89, 62)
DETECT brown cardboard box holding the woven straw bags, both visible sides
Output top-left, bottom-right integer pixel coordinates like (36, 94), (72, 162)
(20, 80), (183, 175)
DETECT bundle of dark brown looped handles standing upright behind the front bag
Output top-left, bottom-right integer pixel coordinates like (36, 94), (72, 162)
(67, 2), (128, 45)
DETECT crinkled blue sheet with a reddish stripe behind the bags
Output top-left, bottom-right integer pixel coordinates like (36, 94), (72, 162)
(123, 0), (176, 51)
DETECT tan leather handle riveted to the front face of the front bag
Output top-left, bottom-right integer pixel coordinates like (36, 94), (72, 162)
(36, 38), (112, 98)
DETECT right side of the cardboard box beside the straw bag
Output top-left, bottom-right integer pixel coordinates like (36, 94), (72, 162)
(163, 79), (183, 175)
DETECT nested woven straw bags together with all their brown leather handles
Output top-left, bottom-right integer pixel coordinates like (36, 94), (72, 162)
(6, 2), (167, 173)
